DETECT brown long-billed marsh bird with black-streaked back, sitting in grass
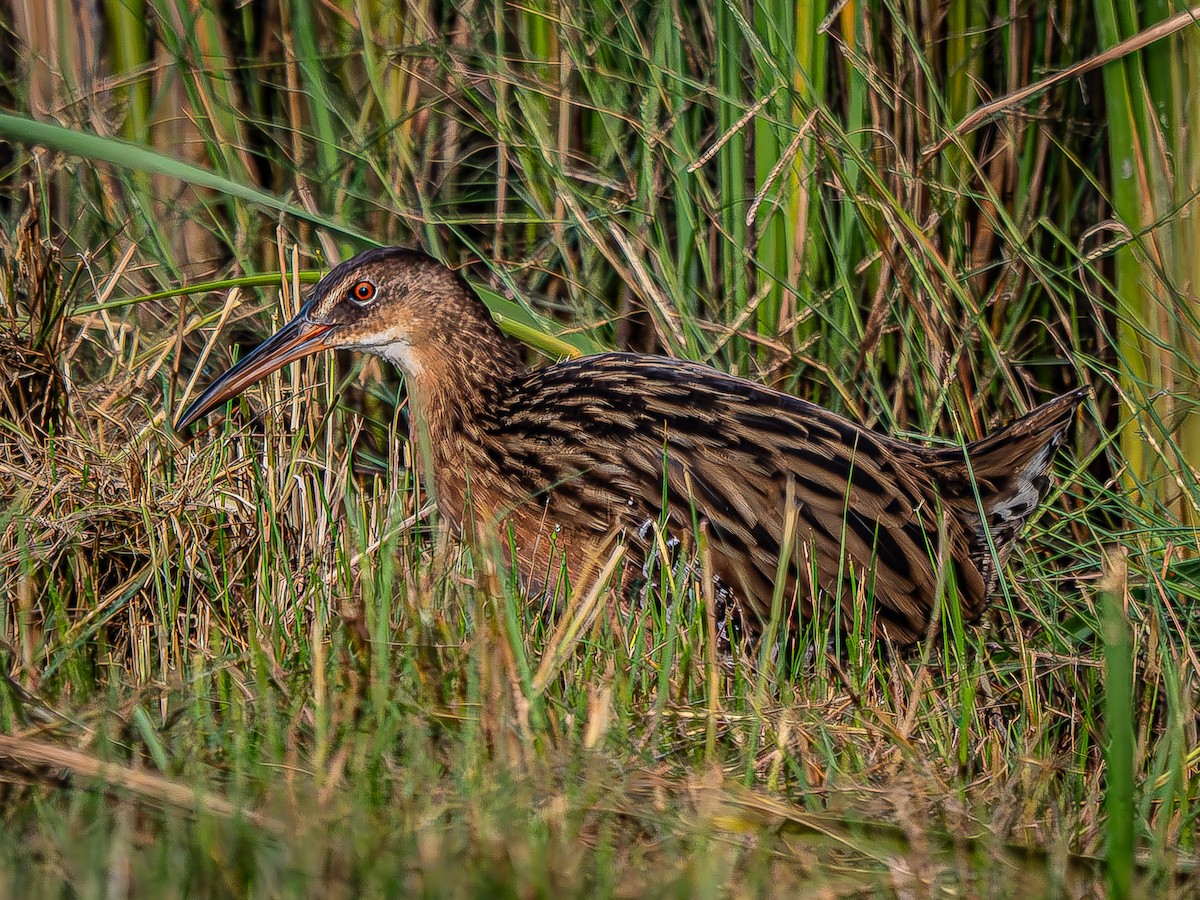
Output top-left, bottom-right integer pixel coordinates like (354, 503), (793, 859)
(175, 247), (1088, 647)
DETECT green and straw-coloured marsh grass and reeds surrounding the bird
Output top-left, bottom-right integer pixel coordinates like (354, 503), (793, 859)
(0, 0), (1200, 896)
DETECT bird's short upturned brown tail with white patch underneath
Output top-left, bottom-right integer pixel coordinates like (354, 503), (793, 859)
(916, 388), (1091, 592)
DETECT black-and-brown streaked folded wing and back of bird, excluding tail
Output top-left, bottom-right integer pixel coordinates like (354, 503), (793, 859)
(499, 354), (998, 640)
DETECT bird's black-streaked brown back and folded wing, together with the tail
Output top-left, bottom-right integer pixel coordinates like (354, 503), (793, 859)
(472, 353), (1079, 643)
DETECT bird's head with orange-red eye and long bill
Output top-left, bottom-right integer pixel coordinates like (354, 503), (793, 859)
(175, 247), (498, 428)
